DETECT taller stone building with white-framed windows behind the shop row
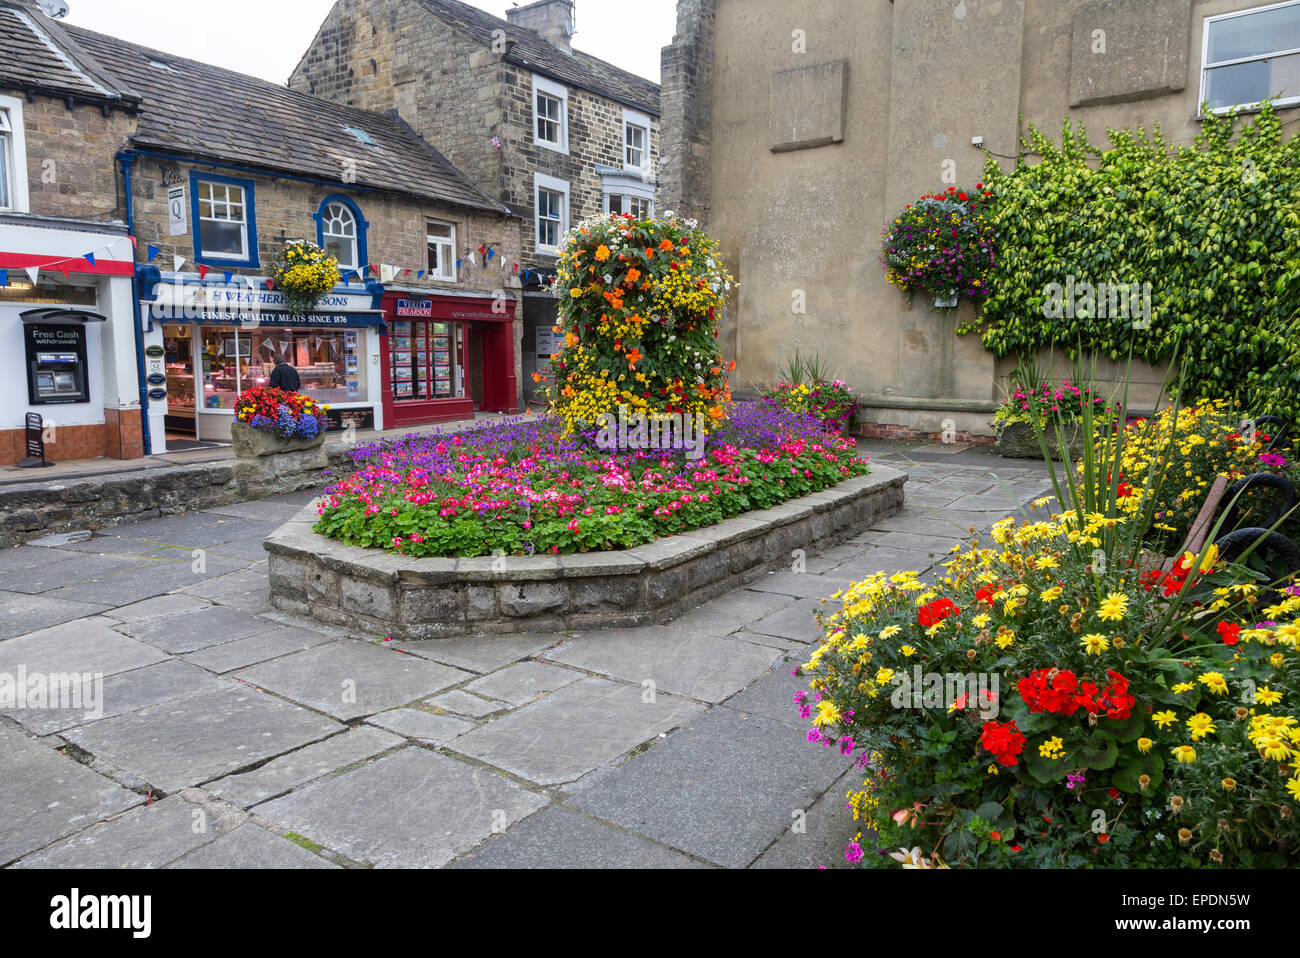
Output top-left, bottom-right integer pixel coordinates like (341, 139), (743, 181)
(289, 0), (660, 402)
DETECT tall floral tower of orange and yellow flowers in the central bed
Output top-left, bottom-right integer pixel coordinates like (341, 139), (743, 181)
(534, 213), (735, 432)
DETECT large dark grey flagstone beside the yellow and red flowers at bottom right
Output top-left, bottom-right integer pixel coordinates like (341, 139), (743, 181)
(567, 708), (852, 868)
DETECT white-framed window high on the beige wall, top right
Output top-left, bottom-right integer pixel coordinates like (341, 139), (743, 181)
(1201, 0), (1300, 113)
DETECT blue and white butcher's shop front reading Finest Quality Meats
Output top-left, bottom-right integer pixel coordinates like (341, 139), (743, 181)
(146, 277), (385, 442)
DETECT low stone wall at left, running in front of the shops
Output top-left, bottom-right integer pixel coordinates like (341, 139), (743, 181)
(0, 443), (340, 549)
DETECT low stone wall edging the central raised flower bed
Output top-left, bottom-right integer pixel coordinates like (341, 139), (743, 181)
(265, 467), (907, 641)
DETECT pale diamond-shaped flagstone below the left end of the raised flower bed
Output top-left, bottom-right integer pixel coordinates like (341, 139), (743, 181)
(237, 640), (473, 720)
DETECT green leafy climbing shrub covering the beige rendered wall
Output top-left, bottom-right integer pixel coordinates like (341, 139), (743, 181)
(958, 105), (1300, 421)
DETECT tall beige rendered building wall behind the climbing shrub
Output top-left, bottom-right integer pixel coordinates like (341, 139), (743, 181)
(660, 0), (1300, 435)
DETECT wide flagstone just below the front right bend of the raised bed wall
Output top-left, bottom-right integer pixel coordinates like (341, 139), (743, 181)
(540, 625), (780, 702)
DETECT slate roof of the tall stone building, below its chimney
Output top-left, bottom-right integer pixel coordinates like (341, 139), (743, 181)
(419, 0), (659, 116)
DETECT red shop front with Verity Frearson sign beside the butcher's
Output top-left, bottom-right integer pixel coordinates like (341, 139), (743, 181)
(380, 292), (516, 429)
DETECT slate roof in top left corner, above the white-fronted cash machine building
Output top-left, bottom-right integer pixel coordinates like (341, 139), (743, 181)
(0, 0), (139, 109)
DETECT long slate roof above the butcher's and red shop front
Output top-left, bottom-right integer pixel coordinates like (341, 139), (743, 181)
(47, 16), (510, 213)
